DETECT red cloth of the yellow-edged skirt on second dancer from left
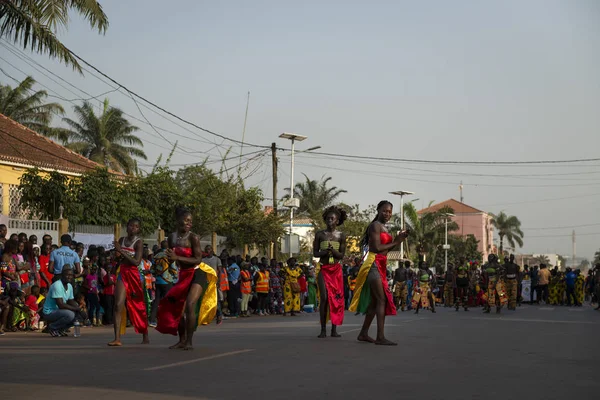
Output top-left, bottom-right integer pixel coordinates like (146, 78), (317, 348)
(156, 268), (196, 335)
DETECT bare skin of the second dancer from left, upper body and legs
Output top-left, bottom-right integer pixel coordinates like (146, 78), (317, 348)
(166, 214), (203, 350)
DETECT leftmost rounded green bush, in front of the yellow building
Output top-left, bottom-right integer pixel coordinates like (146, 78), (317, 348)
(19, 168), (69, 220)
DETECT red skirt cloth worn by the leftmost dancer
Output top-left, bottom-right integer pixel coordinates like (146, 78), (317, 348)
(119, 265), (148, 334)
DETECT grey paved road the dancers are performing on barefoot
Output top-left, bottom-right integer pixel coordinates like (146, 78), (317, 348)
(0, 306), (600, 400)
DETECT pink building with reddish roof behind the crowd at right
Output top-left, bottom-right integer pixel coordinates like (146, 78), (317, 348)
(419, 199), (494, 260)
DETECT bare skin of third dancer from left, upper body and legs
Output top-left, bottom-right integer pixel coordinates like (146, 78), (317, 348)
(313, 212), (346, 338)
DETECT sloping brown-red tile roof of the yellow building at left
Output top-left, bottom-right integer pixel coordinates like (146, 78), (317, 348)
(0, 114), (109, 173)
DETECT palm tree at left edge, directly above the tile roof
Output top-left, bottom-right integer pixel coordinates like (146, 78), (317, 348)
(0, 76), (65, 136)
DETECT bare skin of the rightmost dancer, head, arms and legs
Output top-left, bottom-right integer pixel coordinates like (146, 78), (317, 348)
(357, 204), (408, 346)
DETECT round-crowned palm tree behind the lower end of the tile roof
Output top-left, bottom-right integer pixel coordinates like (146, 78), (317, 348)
(63, 99), (146, 174)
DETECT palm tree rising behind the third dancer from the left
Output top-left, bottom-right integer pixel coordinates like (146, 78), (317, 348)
(284, 174), (348, 228)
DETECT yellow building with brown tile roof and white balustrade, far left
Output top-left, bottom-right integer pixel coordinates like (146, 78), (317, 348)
(0, 114), (101, 243)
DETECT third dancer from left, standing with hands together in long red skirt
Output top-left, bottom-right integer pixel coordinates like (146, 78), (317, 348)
(313, 206), (346, 338)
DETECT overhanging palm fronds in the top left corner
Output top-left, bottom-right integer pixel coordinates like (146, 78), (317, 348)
(0, 0), (108, 72)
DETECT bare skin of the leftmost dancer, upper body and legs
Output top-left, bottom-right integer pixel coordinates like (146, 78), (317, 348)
(108, 221), (150, 346)
